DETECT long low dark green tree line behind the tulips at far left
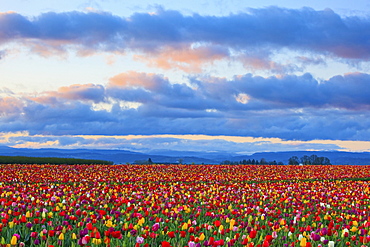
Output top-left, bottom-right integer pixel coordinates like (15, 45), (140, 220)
(0, 156), (113, 165)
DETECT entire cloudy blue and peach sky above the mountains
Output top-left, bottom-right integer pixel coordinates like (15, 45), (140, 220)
(0, 0), (370, 154)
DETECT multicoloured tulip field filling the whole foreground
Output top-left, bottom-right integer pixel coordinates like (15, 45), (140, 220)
(0, 165), (370, 247)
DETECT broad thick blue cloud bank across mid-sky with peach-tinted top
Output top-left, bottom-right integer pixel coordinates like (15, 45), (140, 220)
(0, 72), (370, 140)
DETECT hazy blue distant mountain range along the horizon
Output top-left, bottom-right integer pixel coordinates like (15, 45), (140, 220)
(0, 146), (370, 165)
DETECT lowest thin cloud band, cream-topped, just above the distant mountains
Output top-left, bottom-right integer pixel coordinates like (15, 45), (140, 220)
(0, 132), (346, 154)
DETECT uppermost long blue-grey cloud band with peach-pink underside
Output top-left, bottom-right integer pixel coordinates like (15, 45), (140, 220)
(0, 7), (370, 67)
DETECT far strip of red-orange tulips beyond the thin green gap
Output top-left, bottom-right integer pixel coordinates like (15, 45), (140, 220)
(0, 164), (370, 183)
